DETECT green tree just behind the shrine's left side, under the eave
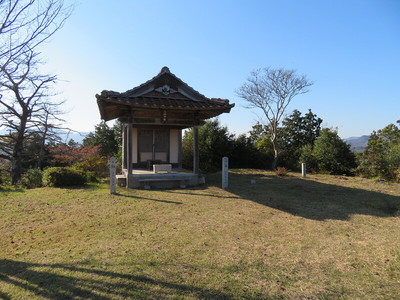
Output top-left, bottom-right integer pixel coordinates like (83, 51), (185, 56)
(83, 121), (120, 157)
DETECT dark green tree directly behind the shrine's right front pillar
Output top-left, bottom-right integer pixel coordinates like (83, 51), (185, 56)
(182, 119), (233, 172)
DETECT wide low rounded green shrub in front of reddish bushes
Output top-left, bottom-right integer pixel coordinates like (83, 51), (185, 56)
(43, 167), (86, 187)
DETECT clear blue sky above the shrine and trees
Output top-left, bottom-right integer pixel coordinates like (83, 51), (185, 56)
(42, 0), (400, 138)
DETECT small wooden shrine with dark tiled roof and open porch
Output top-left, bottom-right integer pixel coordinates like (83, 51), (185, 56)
(96, 67), (235, 189)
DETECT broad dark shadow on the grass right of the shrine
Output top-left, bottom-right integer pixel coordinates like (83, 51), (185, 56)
(210, 172), (400, 221)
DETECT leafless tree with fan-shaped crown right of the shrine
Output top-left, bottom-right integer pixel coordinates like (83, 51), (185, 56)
(236, 68), (312, 169)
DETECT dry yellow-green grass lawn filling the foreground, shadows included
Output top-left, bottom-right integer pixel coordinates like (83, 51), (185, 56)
(0, 170), (400, 299)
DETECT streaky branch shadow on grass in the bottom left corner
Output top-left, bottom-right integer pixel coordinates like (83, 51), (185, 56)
(0, 259), (231, 300)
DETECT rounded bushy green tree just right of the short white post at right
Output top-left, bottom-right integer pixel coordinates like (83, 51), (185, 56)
(313, 128), (357, 175)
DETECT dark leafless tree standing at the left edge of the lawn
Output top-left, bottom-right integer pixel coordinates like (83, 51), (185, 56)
(0, 52), (61, 184)
